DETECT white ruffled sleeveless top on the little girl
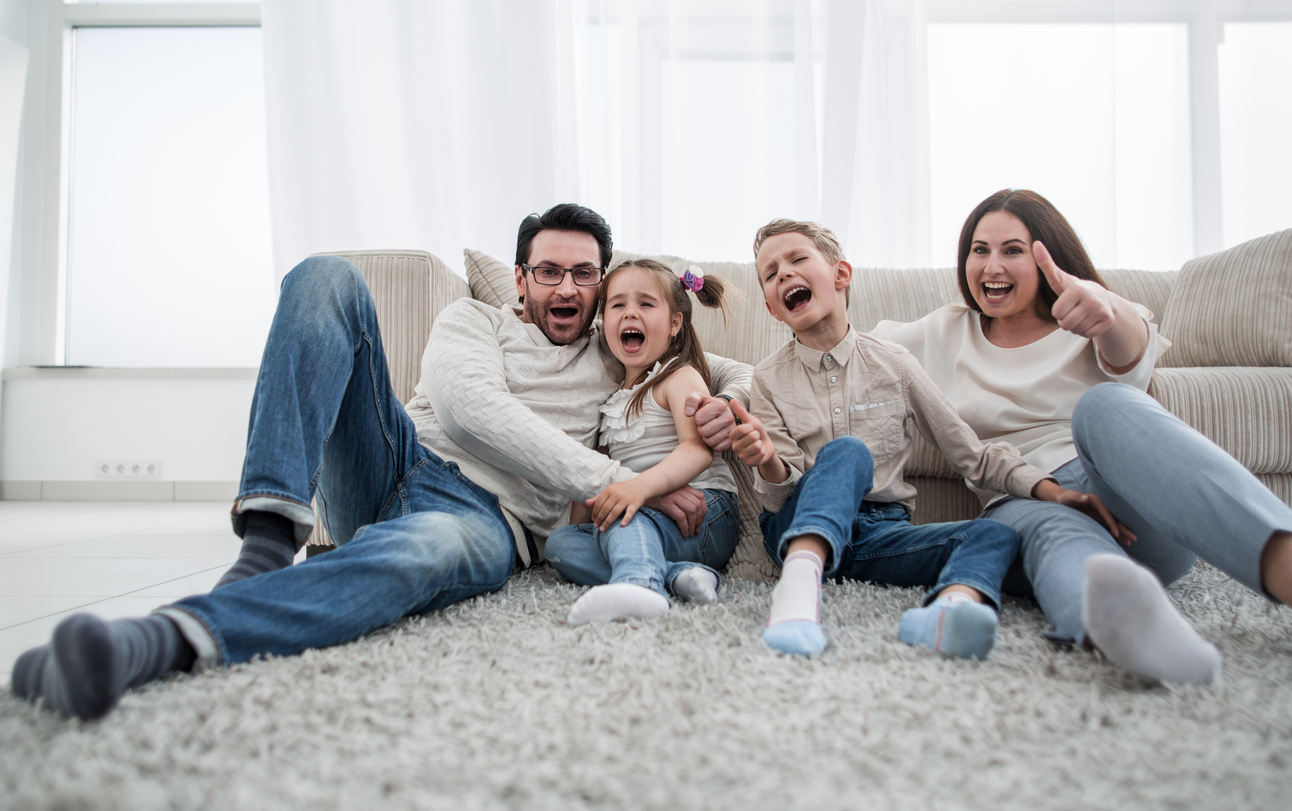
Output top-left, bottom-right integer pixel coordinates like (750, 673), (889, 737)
(601, 360), (736, 493)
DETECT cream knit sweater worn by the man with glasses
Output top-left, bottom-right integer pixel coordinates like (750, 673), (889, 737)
(407, 298), (751, 564)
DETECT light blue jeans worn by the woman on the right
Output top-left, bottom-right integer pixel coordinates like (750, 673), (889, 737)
(983, 384), (1292, 643)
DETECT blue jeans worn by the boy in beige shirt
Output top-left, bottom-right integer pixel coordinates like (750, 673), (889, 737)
(758, 436), (1018, 608)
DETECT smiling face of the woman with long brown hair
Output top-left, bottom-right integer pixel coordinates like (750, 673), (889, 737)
(965, 212), (1049, 320)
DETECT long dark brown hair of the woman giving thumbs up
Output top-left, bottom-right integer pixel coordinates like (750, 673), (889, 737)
(956, 189), (1107, 313)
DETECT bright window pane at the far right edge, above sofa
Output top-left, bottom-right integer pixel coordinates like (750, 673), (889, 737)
(1220, 22), (1292, 248)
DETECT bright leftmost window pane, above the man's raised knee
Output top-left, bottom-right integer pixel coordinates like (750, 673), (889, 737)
(67, 27), (276, 367)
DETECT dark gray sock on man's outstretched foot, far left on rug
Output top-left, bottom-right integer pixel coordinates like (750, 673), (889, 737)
(13, 613), (196, 721)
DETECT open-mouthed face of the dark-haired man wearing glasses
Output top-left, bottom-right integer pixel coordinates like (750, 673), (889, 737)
(516, 230), (601, 346)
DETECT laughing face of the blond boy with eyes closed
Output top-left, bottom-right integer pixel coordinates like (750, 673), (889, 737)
(755, 231), (853, 349)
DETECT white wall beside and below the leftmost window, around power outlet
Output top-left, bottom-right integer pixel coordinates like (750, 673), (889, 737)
(0, 0), (256, 498)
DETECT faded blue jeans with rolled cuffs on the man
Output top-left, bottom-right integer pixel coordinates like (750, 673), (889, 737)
(159, 257), (516, 665)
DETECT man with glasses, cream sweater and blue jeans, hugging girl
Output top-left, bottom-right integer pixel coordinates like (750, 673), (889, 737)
(13, 204), (749, 719)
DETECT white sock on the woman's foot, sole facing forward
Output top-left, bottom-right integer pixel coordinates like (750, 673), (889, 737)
(1081, 554), (1221, 684)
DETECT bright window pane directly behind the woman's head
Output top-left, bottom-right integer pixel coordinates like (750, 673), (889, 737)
(929, 23), (1193, 270)
